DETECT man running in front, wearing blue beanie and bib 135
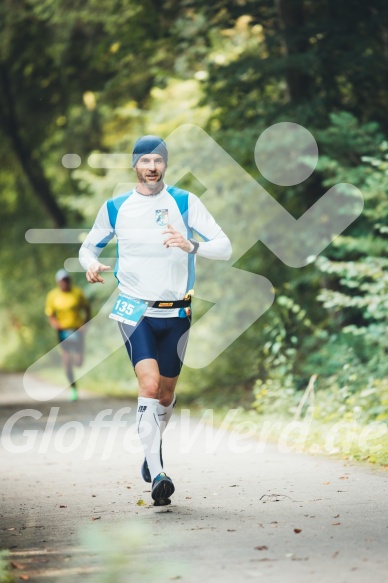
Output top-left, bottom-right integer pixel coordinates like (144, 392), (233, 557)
(80, 136), (232, 506)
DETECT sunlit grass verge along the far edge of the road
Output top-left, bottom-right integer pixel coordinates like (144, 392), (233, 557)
(34, 367), (388, 468)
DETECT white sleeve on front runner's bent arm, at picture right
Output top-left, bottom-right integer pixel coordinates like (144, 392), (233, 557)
(188, 193), (232, 261)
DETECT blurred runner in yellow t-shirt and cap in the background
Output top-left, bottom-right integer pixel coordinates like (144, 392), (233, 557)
(45, 269), (90, 401)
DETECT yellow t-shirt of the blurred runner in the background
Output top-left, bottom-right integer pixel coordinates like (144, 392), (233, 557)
(45, 287), (89, 330)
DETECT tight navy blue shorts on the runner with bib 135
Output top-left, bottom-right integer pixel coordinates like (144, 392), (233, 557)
(119, 316), (191, 378)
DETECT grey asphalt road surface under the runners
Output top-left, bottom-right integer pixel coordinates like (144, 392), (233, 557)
(0, 375), (388, 583)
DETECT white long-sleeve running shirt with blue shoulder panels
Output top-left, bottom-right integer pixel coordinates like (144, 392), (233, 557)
(79, 185), (232, 318)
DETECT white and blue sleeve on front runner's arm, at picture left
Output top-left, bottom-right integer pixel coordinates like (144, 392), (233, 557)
(79, 203), (115, 271)
